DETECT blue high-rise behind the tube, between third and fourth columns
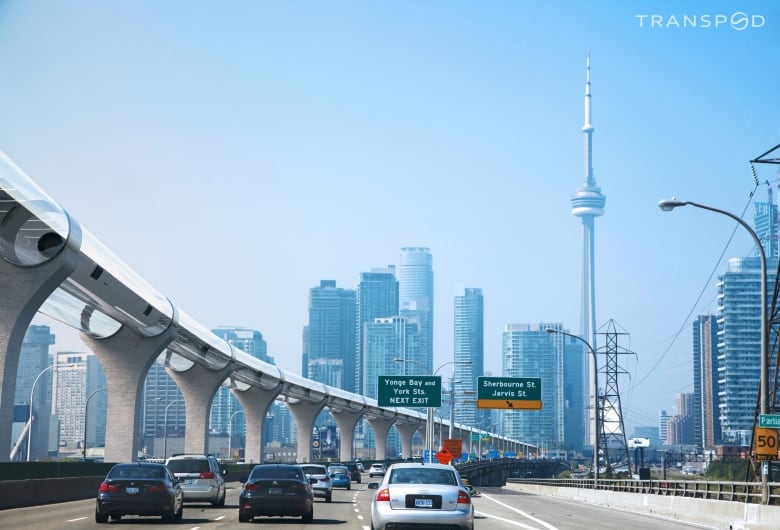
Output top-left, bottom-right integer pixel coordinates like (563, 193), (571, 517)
(209, 326), (275, 447)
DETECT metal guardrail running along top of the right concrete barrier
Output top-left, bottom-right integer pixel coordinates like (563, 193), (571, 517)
(506, 477), (780, 506)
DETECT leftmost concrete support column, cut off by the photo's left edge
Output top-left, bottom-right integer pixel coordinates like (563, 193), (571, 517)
(0, 248), (78, 462)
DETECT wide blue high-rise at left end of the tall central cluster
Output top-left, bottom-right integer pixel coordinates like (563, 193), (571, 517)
(303, 280), (356, 392)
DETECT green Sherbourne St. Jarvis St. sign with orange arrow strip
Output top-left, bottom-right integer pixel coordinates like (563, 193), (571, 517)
(477, 377), (542, 410)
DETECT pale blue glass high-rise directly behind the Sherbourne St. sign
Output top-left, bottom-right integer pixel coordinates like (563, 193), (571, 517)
(501, 323), (565, 455)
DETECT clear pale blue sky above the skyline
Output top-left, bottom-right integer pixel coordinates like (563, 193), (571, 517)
(0, 0), (780, 435)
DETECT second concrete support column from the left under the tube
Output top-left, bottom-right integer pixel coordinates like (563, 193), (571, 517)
(81, 327), (175, 462)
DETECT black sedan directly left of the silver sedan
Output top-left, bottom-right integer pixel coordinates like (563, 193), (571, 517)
(238, 464), (317, 523)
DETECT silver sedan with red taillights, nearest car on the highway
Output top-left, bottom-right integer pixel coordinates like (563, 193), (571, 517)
(368, 462), (474, 530)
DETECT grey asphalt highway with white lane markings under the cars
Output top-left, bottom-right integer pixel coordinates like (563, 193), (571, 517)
(0, 480), (708, 530)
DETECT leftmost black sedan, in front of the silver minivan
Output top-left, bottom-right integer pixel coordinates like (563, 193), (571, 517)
(95, 462), (184, 523)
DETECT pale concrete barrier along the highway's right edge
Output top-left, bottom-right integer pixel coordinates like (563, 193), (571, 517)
(506, 483), (780, 530)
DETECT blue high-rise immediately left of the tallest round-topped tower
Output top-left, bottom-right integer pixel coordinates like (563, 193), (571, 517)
(355, 265), (398, 395)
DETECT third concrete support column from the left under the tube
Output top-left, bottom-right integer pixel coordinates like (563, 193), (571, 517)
(166, 364), (232, 454)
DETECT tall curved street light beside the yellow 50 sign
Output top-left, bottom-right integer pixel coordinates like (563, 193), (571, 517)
(658, 199), (769, 504)
